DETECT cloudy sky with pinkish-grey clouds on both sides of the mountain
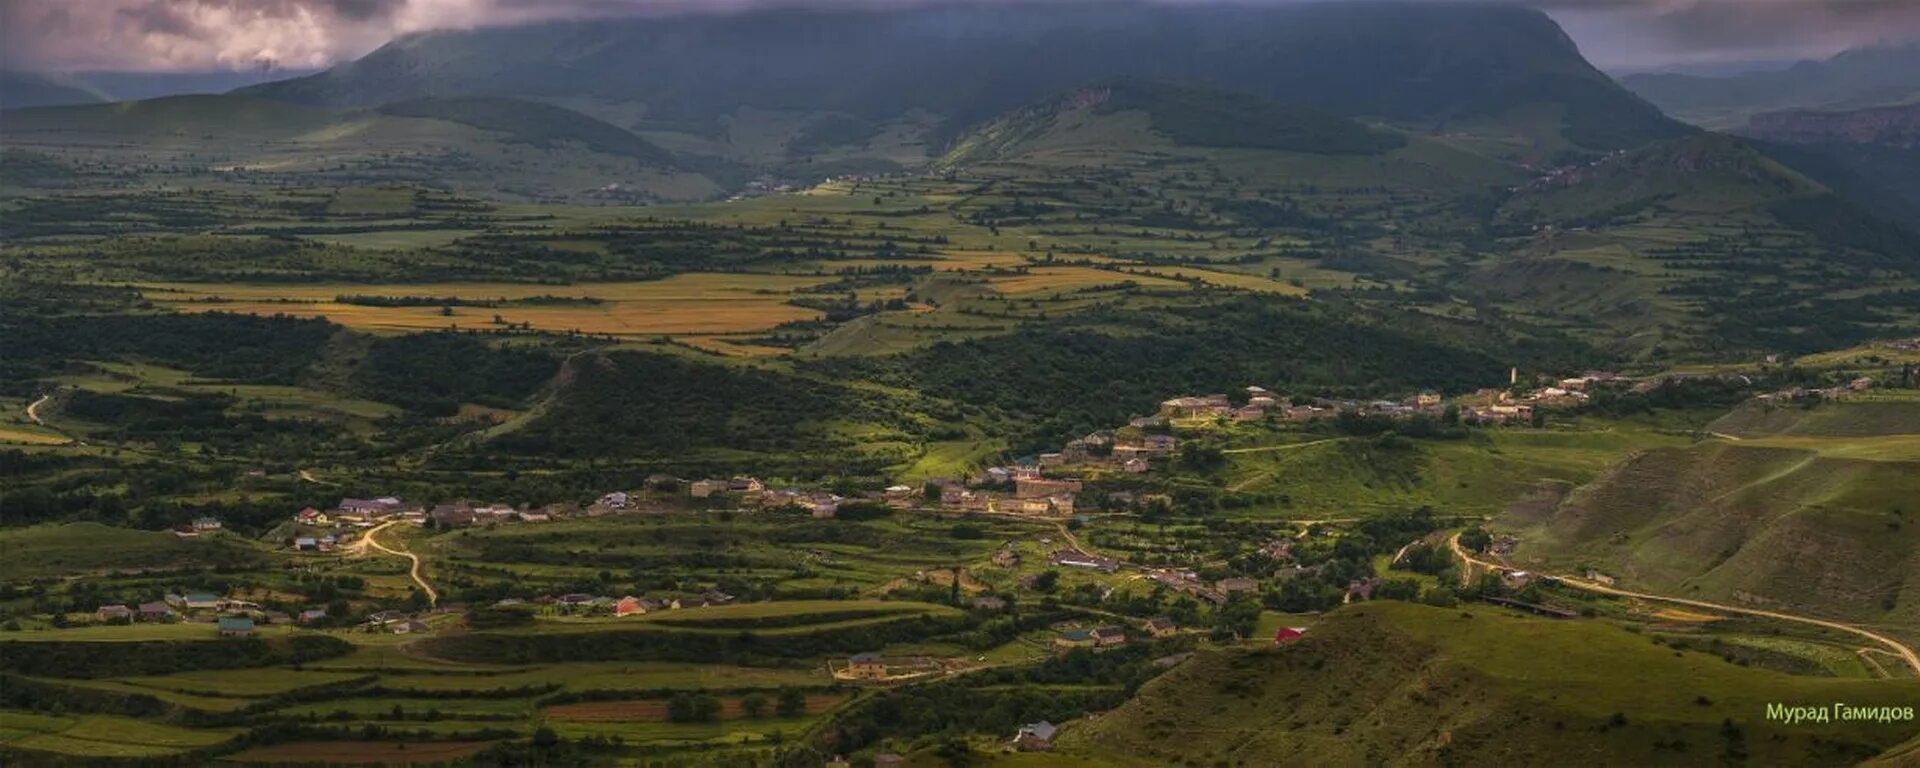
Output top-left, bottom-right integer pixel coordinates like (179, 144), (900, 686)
(0, 0), (1920, 71)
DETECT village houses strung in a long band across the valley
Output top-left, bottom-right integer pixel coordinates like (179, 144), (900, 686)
(123, 371), (1651, 645)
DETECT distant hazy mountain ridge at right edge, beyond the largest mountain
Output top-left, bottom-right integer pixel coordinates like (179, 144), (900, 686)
(1620, 44), (1920, 129)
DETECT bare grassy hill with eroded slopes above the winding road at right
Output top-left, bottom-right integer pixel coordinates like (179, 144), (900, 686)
(1501, 401), (1920, 622)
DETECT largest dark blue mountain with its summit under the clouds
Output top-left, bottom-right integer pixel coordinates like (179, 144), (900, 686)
(244, 2), (1682, 148)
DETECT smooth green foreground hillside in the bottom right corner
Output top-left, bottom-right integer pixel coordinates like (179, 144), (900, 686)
(1060, 603), (1916, 766)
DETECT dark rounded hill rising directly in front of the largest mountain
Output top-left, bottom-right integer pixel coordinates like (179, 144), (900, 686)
(943, 79), (1405, 165)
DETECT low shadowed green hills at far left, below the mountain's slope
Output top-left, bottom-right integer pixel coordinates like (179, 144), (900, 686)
(0, 94), (732, 202)
